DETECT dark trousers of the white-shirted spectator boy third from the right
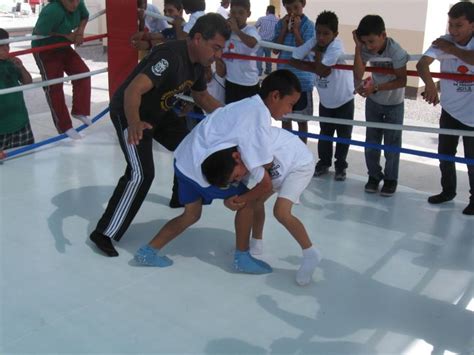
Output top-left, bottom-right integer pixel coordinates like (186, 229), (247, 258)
(318, 99), (354, 170)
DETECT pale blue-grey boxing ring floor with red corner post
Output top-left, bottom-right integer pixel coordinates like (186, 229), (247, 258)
(0, 0), (474, 355)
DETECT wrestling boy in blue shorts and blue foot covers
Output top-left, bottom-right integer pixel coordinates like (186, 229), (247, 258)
(135, 70), (301, 274)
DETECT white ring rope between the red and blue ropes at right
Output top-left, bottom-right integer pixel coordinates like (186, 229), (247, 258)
(175, 94), (474, 137)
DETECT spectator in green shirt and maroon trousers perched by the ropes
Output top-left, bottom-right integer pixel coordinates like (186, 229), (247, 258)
(31, 0), (92, 139)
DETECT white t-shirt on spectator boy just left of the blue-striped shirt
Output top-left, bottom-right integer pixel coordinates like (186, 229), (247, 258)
(224, 26), (261, 86)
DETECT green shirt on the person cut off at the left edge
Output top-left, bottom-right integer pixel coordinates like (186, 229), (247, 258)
(0, 60), (28, 134)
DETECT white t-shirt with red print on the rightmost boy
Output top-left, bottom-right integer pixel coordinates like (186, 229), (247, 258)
(424, 35), (474, 127)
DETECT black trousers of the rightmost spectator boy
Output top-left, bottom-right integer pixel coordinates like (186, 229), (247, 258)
(438, 110), (474, 202)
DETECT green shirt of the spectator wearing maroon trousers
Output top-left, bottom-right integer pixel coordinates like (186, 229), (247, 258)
(31, 0), (89, 47)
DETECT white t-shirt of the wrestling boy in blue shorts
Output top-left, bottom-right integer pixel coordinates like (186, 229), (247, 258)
(174, 95), (273, 187)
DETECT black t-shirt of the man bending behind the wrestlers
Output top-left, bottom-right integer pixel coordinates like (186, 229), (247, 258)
(110, 40), (206, 125)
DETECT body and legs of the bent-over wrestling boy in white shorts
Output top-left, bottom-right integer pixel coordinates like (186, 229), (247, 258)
(231, 127), (321, 286)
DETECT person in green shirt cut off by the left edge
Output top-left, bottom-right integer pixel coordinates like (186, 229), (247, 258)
(0, 28), (34, 154)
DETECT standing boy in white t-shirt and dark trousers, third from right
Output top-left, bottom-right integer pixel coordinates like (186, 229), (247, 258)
(290, 11), (354, 181)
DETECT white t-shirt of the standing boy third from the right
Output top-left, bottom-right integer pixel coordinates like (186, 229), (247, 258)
(293, 37), (354, 108)
